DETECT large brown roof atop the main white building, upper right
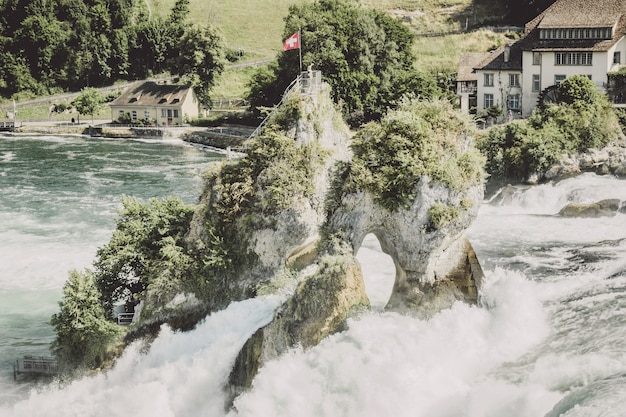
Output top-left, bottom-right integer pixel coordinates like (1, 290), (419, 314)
(518, 0), (626, 51)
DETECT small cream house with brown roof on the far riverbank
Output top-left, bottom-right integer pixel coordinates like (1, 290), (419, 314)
(109, 81), (200, 126)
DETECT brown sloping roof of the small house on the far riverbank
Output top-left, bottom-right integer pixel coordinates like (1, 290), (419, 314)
(109, 81), (191, 107)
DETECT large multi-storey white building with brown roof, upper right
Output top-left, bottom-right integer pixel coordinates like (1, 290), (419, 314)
(474, 0), (626, 117)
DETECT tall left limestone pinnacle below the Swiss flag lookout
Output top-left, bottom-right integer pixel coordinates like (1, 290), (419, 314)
(183, 75), (350, 301)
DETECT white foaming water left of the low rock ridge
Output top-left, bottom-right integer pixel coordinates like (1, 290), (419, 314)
(0, 297), (280, 417)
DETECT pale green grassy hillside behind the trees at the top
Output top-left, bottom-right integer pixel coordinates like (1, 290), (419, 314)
(155, 0), (505, 98)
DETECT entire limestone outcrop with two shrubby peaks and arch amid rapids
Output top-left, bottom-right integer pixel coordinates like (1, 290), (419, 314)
(118, 74), (484, 399)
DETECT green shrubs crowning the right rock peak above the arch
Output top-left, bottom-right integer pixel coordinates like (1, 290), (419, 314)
(342, 96), (484, 210)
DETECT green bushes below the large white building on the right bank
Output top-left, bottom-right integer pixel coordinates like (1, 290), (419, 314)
(478, 76), (619, 181)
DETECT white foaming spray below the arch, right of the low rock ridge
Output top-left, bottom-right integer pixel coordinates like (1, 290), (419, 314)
(231, 270), (558, 417)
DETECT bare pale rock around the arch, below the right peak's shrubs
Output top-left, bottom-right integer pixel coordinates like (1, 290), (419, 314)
(329, 177), (483, 316)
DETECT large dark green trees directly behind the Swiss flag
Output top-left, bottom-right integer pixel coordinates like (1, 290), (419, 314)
(250, 0), (438, 122)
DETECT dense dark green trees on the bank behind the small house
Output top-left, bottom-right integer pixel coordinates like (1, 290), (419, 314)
(0, 0), (224, 102)
